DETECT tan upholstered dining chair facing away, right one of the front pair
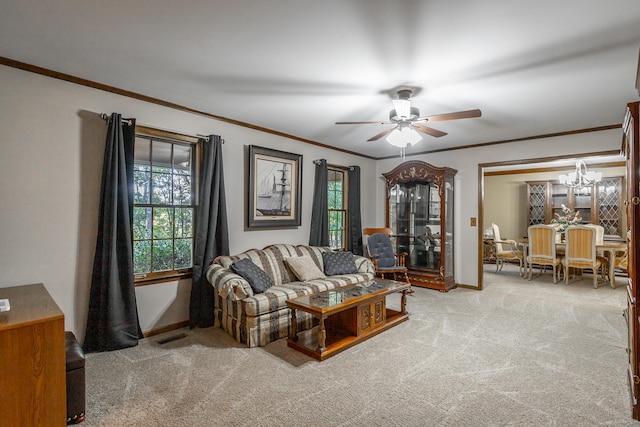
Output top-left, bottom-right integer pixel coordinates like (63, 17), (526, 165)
(562, 225), (608, 288)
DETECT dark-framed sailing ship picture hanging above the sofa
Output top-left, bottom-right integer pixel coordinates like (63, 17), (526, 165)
(245, 145), (302, 230)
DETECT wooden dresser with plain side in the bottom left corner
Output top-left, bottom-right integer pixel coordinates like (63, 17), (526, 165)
(0, 283), (67, 426)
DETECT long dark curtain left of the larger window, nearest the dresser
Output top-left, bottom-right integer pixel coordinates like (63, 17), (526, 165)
(84, 113), (142, 351)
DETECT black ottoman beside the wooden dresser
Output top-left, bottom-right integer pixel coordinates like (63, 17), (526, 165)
(65, 331), (85, 424)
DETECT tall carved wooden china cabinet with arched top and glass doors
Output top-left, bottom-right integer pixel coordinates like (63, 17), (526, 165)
(382, 160), (457, 292)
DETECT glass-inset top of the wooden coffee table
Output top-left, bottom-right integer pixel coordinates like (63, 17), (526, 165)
(294, 279), (409, 309)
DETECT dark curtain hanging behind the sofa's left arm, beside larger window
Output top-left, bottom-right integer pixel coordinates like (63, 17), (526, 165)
(189, 135), (229, 328)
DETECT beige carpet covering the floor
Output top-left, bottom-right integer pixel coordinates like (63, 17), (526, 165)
(83, 266), (640, 427)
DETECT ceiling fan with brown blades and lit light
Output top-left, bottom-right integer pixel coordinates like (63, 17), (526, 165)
(336, 88), (482, 145)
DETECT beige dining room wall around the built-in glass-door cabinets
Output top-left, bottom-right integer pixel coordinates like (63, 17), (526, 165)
(484, 166), (626, 239)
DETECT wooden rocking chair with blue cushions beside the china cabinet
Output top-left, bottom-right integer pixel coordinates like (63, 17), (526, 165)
(362, 228), (411, 283)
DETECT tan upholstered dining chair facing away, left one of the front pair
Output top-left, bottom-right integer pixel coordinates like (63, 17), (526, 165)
(527, 224), (561, 283)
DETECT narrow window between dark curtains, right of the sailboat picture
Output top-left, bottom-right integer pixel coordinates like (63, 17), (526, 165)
(327, 166), (347, 250)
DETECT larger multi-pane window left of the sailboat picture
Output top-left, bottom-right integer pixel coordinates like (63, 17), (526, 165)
(133, 135), (196, 282)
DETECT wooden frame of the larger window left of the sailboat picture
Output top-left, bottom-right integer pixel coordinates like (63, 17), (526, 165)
(131, 126), (201, 287)
